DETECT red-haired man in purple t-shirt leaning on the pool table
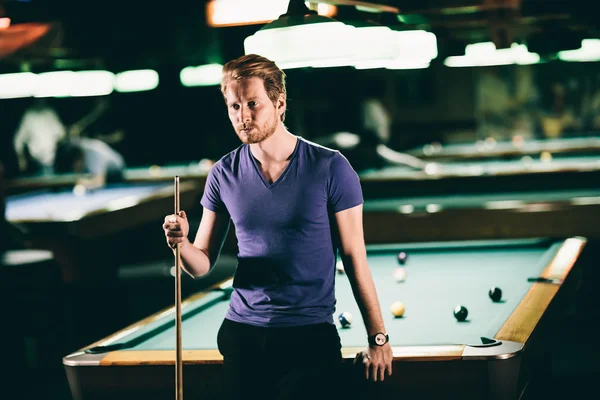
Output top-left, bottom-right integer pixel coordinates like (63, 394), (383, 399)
(163, 55), (393, 399)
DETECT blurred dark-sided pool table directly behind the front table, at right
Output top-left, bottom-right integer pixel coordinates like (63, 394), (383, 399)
(363, 189), (600, 244)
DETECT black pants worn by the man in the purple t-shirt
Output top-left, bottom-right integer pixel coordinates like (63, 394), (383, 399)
(217, 319), (360, 400)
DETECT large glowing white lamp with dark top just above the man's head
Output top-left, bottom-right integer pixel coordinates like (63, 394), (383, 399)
(244, 0), (355, 69)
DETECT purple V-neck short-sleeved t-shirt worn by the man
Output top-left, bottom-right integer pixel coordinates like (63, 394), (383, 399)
(201, 138), (363, 327)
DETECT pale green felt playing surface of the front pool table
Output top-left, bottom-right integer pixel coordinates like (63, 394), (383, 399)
(98, 240), (559, 350)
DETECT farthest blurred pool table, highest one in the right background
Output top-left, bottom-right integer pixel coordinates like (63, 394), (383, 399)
(407, 135), (600, 160)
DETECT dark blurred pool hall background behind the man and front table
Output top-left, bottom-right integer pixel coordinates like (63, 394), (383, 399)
(0, 0), (600, 399)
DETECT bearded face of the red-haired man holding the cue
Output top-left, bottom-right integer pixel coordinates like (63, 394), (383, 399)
(225, 77), (284, 144)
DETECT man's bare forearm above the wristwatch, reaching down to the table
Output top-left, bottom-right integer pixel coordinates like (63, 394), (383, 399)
(342, 254), (386, 335)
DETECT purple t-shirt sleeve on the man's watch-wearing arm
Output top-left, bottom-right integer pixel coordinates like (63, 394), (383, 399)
(328, 152), (363, 213)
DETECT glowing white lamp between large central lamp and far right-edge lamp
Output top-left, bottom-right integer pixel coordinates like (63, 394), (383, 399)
(444, 42), (540, 67)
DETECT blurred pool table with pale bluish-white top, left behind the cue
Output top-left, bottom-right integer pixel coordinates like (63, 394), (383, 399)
(6, 181), (201, 283)
